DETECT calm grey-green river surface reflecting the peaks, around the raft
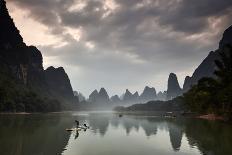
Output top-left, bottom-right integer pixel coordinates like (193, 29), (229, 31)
(0, 112), (232, 155)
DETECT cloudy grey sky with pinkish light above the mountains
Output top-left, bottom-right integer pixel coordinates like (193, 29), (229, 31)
(6, 0), (232, 96)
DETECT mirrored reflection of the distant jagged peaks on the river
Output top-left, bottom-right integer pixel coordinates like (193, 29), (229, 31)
(88, 114), (183, 151)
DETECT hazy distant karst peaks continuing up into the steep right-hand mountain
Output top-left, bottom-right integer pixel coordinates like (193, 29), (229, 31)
(86, 26), (232, 105)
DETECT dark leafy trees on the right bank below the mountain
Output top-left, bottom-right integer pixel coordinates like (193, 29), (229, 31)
(184, 45), (232, 119)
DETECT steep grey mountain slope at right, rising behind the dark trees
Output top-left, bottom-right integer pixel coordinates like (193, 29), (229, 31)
(184, 26), (232, 92)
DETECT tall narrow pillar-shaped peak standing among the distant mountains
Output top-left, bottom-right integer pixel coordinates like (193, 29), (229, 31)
(167, 73), (182, 100)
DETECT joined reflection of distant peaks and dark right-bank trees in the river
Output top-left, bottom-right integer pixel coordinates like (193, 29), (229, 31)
(82, 115), (232, 155)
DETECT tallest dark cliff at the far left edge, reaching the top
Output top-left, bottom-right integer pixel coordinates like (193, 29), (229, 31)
(0, 0), (43, 84)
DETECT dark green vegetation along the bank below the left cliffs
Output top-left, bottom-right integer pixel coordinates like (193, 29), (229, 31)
(0, 66), (60, 112)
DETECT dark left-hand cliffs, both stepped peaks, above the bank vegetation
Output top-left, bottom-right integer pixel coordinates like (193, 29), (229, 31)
(0, 0), (74, 107)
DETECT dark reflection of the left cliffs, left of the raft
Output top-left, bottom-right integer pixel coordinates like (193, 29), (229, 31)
(0, 115), (74, 155)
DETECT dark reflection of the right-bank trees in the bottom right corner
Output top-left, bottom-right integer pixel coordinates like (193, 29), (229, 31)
(185, 120), (232, 155)
